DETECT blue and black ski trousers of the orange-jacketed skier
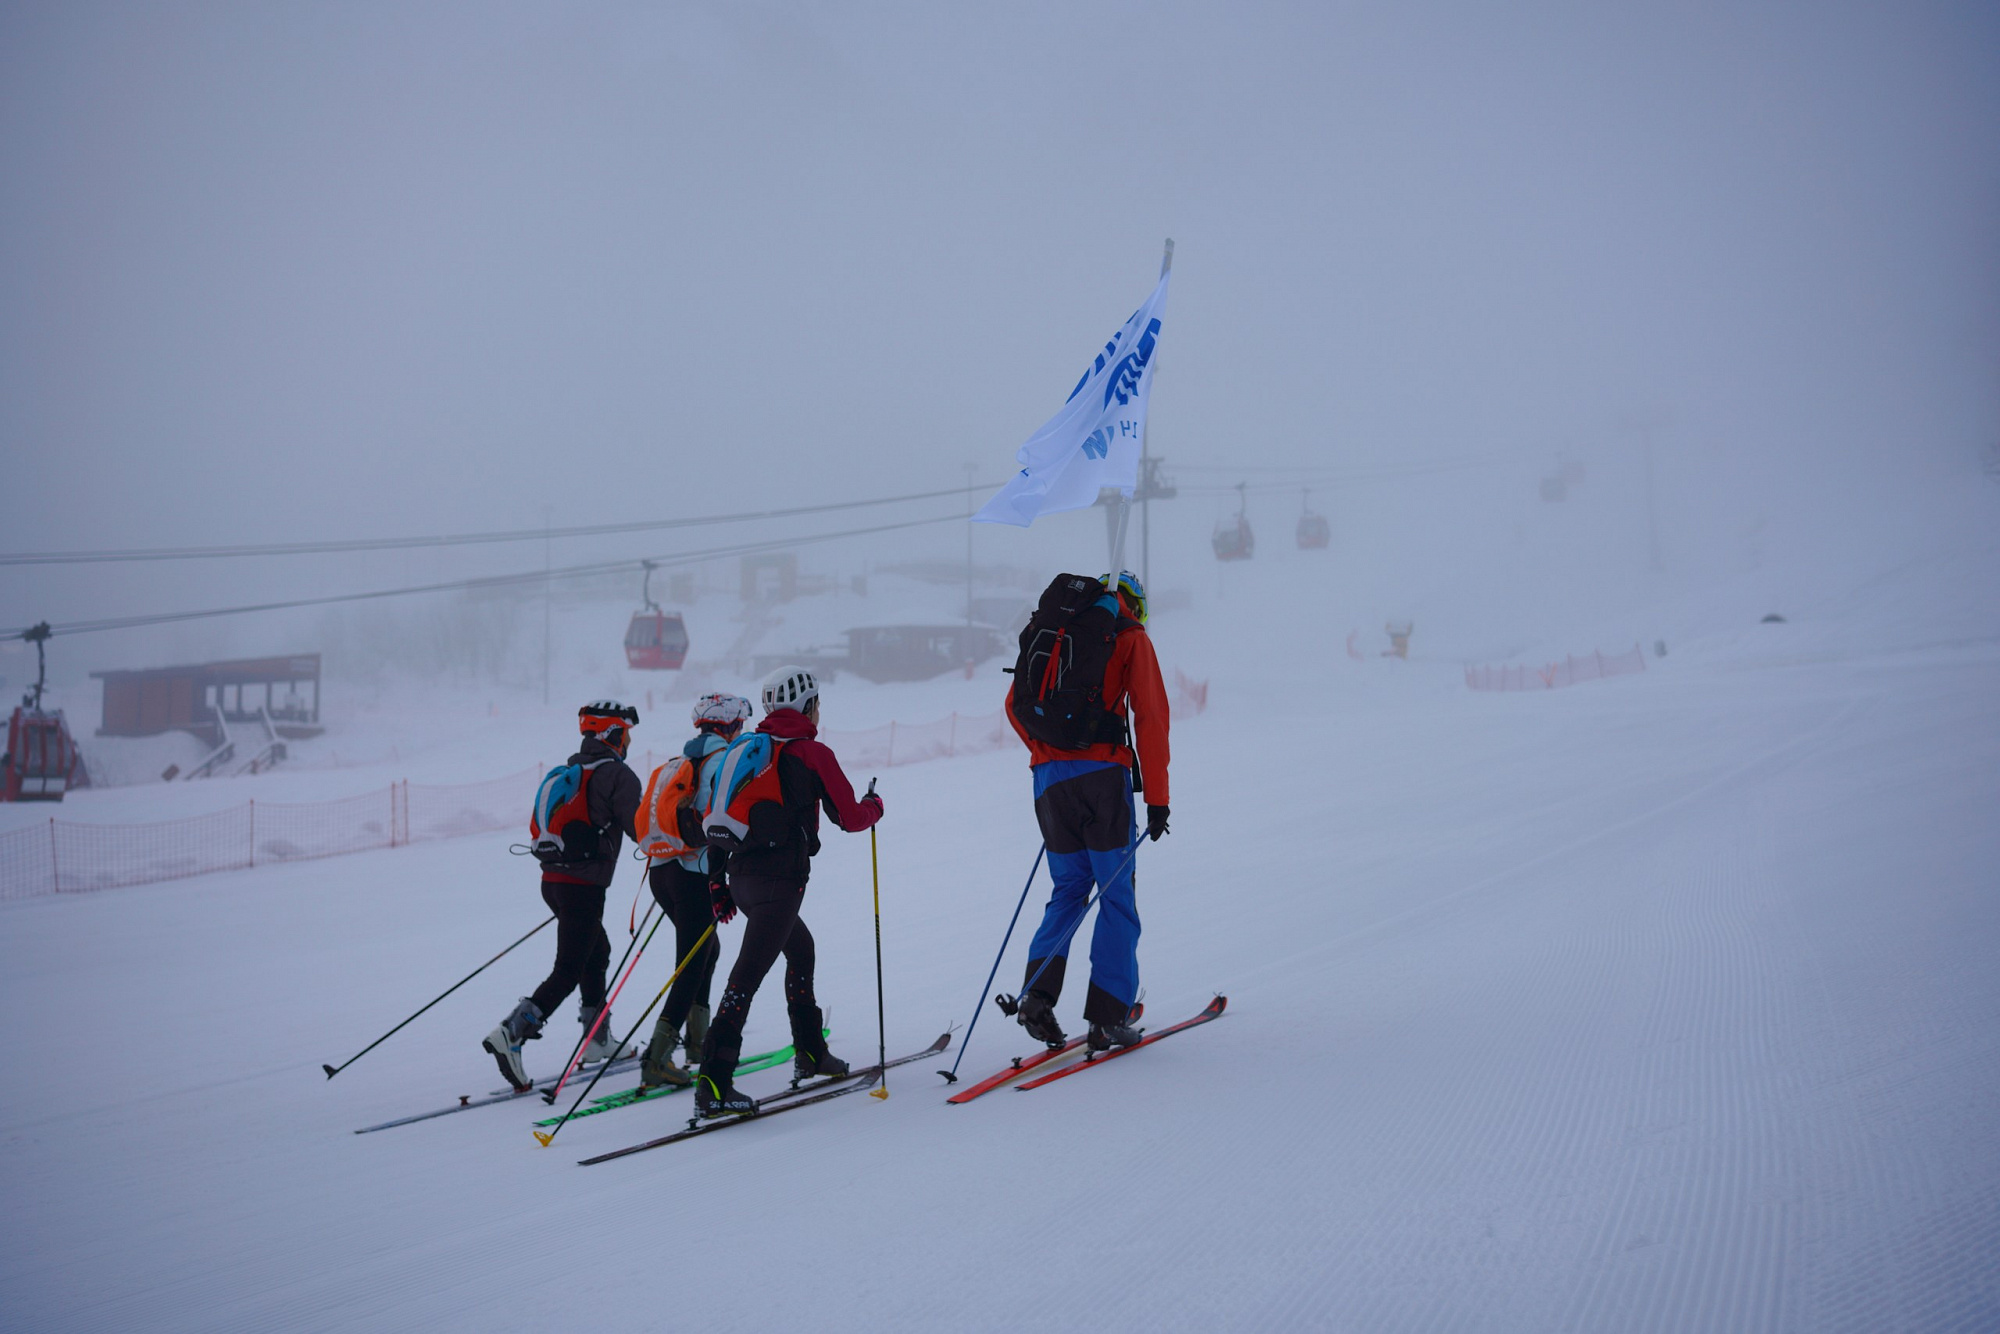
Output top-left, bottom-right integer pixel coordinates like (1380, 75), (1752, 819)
(1024, 760), (1138, 1024)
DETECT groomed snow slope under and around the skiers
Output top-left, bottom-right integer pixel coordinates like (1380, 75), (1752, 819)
(0, 644), (2000, 1332)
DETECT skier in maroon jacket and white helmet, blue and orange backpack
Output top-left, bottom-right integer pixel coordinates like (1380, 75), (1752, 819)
(694, 666), (882, 1116)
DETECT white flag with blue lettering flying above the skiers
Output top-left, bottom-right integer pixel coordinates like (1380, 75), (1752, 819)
(972, 274), (1172, 528)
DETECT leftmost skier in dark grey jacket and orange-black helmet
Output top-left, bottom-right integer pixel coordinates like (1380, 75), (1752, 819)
(482, 700), (640, 1092)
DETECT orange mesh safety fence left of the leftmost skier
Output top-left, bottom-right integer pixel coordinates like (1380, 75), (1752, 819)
(0, 770), (540, 902)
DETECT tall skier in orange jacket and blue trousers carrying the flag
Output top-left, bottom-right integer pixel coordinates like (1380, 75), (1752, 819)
(1006, 570), (1168, 1052)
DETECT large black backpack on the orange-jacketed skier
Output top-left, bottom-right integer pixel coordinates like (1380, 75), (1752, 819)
(1012, 574), (1138, 750)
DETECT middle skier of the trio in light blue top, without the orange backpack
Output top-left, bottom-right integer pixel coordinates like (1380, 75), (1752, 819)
(640, 692), (756, 1088)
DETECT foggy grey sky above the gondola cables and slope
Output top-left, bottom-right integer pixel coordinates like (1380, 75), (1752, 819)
(0, 4), (2000, 624)
